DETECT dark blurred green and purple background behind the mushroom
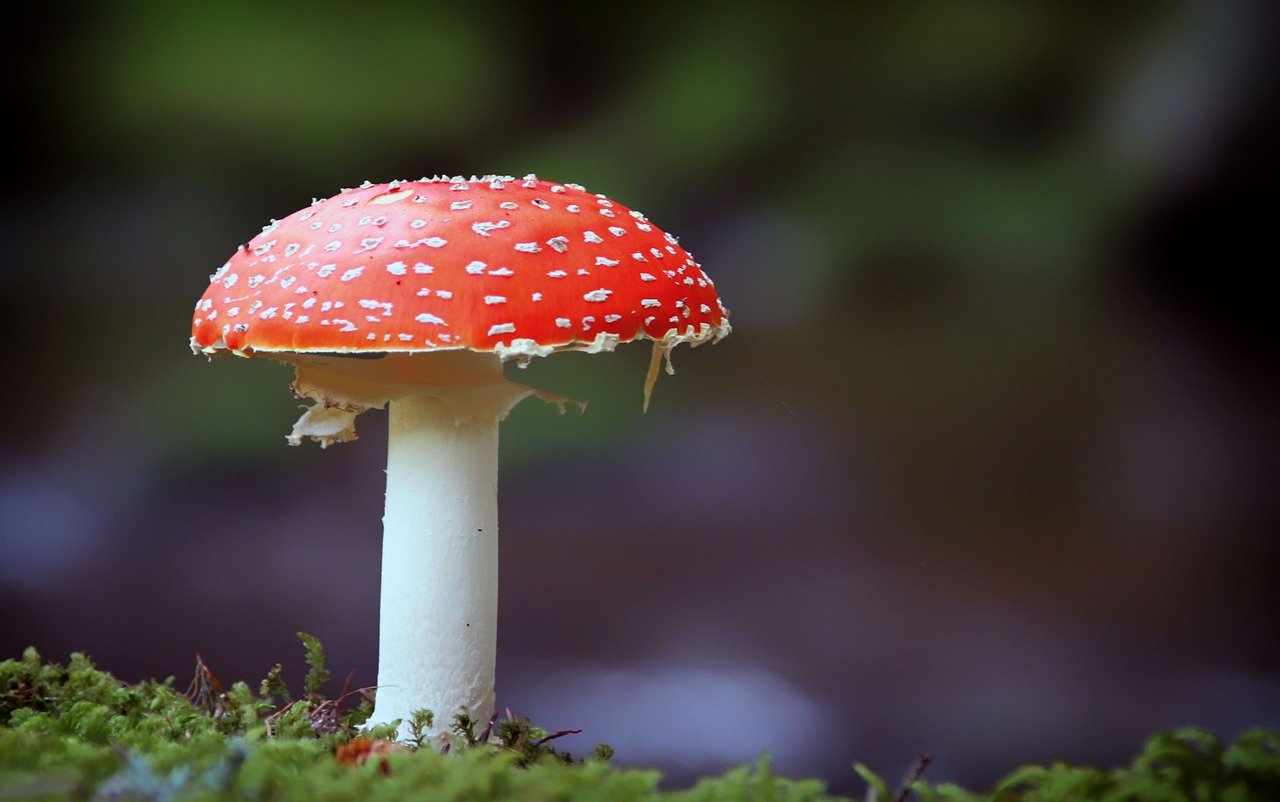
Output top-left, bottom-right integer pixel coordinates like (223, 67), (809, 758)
(0, 0), (1280, 793)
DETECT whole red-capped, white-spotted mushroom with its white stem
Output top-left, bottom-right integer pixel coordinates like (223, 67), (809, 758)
(191, 175), (730, 735)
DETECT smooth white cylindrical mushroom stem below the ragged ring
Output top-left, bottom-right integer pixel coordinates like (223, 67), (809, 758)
(371, 395), (498, 738)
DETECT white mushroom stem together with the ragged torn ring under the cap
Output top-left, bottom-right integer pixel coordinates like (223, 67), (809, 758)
(280, 350), (542, 746)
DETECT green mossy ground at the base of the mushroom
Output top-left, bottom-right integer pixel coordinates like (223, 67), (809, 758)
(0, 636), (1280, 802)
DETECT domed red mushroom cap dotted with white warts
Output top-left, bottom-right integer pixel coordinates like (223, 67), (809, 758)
(191, 175), (730, 359)
